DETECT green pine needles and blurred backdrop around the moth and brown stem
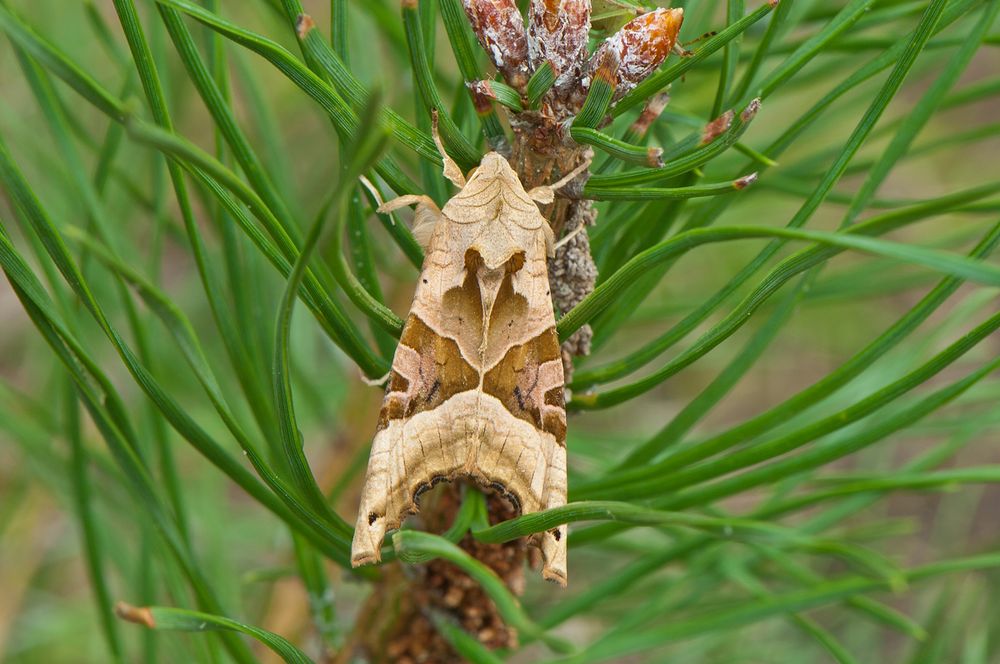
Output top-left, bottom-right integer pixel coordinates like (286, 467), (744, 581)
(0, 0), (1000, 664)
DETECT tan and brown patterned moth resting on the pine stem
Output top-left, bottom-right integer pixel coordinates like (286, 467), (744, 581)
(351, 132), (587, 585)
